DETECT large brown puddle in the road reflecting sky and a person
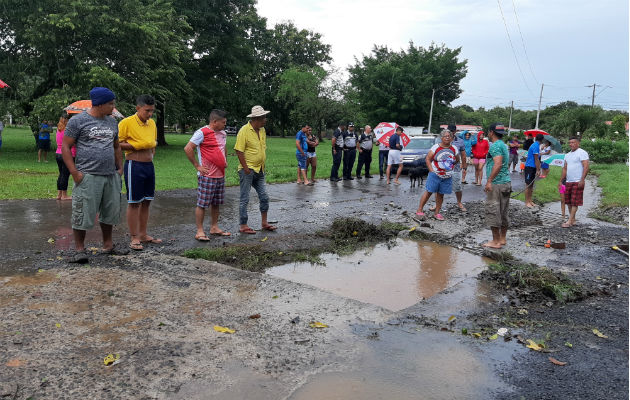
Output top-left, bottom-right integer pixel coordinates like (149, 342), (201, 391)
(266, 239), (488, 311)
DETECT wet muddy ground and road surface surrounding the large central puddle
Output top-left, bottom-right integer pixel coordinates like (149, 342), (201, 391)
(0, 176), (628, 399)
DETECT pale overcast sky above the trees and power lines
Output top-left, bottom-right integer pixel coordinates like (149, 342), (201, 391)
(257, 0), (629, 110)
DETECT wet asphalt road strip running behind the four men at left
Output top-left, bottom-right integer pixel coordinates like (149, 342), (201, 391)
(0, 174), (524, 266)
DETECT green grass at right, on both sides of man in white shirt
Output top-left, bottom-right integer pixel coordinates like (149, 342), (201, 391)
(516, 164), (628, 207)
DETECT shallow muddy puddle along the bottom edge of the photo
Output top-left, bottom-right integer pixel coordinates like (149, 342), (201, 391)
(289, 329), (513, 400)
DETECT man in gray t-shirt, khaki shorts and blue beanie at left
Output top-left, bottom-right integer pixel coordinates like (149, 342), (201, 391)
(61, 87), (122, 263)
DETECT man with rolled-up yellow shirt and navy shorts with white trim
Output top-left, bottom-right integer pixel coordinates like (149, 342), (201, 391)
(118, 94), (162, 250)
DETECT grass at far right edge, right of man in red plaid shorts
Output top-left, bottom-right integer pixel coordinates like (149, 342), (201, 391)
(591, 164), (629, 207)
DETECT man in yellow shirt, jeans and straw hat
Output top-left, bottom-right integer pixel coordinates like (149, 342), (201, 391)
(234, 106), (276, 235)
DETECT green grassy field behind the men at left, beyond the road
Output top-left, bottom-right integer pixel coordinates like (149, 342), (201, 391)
(0, 128), (378, 199)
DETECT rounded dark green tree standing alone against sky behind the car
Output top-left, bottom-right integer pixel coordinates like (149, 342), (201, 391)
(348, 42), (467, 125)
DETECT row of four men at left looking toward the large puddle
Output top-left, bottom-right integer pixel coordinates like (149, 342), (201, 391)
(63, 87), (276, 263)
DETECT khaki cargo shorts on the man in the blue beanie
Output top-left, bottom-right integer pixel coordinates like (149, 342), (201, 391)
(72, 174), (122, 231)
